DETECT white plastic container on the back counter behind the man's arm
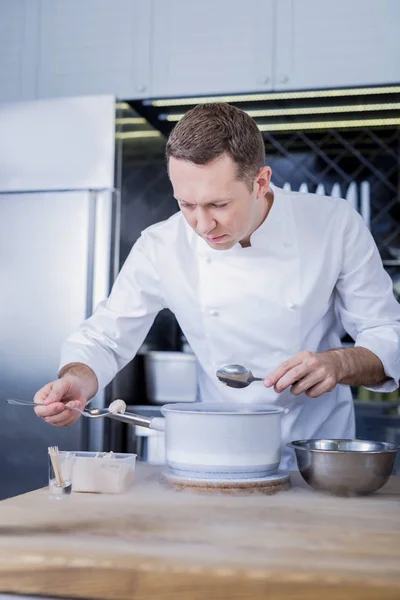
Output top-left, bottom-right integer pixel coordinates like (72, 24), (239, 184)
(145, 351), (197, 404)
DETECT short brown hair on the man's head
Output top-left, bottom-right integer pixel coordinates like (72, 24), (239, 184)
(165, 102), (265, 187)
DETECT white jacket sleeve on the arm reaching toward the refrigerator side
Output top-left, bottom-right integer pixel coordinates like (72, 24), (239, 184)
(60, 236), (165, 390)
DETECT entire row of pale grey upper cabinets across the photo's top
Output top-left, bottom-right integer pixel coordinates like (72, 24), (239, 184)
(0, 0), (400, 101)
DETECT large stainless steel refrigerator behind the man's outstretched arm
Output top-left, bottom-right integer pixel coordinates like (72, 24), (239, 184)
(0, 96), (119, 499)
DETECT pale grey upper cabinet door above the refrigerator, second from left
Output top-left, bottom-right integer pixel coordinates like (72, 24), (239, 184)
(38, 0), (152, 98)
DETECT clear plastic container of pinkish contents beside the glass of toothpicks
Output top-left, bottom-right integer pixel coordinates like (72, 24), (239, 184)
(72, 452), (136, 494)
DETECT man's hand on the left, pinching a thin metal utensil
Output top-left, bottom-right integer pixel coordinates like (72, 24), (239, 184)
(34, 375), (87, 427)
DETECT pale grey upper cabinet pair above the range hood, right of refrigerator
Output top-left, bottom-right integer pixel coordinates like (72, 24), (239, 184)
(153, 0), (400, 97)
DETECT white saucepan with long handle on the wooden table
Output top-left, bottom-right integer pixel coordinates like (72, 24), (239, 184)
(112, 402), (283, 478)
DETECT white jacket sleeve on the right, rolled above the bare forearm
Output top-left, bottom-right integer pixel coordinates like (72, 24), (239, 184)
(336, 206), (400, 392)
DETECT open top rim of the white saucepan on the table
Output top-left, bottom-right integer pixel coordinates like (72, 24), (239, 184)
(161, 402), (283, 415)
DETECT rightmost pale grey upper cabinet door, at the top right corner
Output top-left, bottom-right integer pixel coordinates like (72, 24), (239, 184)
(274, 0), (400, 89)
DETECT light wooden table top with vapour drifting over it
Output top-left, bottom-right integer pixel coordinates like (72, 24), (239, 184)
(0, 465), (400, 600)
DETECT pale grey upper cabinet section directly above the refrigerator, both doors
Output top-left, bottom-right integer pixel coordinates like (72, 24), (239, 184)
(0, 0), (152, 102)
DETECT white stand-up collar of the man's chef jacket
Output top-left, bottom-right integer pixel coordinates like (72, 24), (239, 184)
(185, 183), (287, 255)
